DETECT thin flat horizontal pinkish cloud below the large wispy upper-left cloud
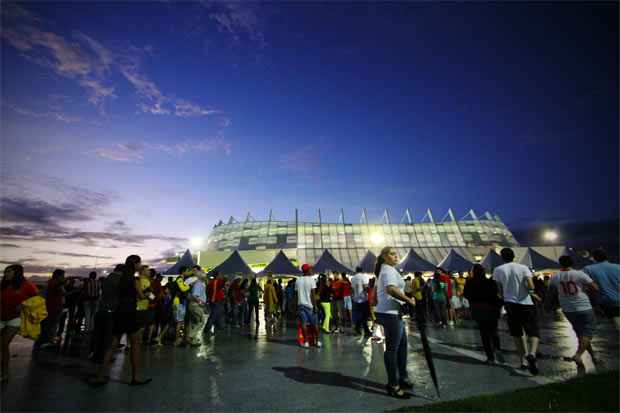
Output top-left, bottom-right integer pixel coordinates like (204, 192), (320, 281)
(91, 137), (232, 162)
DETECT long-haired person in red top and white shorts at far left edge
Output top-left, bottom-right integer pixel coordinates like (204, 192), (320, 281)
(0, 264), (37, 382)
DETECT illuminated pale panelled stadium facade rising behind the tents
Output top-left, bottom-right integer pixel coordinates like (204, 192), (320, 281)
(199, 210), (559, 268)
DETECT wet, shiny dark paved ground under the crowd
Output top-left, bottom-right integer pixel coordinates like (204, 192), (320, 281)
(2, 315), (618, 412)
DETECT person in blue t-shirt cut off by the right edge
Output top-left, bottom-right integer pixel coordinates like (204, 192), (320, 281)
(583, 248), (620, 331)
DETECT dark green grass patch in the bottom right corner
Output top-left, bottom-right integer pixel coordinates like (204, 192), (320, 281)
(394, 370), (619, 412)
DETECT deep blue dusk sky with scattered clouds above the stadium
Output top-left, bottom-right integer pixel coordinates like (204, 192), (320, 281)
(0, 1), (620, 271)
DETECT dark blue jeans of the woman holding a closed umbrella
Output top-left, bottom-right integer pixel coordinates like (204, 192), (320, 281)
(376, 313), (409, 387)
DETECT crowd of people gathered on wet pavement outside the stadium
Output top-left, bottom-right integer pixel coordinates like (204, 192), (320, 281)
(0, 247), (620, 398)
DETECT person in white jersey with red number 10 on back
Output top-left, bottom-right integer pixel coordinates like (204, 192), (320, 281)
(550, 255), (598, 368)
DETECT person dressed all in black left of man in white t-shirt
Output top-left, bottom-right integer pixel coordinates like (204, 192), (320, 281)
(462, 264), (504, 364)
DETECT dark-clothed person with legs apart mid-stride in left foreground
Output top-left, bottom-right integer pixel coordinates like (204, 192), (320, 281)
(91, 255), (152, 386)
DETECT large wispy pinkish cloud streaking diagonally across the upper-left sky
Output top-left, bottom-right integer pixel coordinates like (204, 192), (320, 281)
(2, 2), (220, 118)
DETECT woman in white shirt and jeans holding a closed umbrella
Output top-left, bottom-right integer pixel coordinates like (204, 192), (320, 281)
(375, 247), (415, 399)
